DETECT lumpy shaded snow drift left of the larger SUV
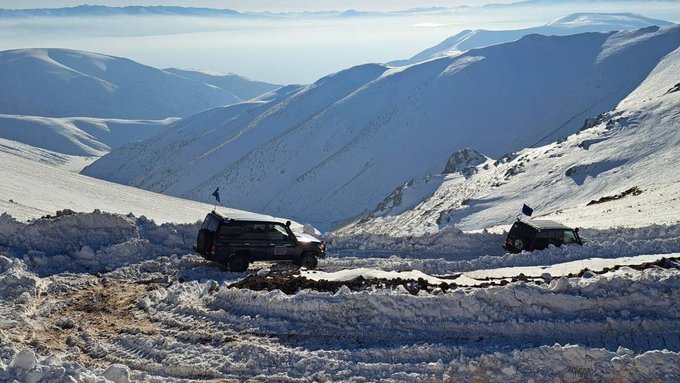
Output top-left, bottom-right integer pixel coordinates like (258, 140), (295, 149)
(0, 211), (200, 275)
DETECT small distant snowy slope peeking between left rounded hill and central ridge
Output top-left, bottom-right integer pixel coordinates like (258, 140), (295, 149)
(163, 68), (281, 101)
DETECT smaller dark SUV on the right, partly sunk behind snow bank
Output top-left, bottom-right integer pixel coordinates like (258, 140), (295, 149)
(503, 220), (583, 253)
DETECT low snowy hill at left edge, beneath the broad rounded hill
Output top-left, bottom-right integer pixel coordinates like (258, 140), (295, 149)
(0, 114), (176, 156)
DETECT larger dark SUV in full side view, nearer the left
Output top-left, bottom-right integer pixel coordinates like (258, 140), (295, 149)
(196, 210), (326, 272)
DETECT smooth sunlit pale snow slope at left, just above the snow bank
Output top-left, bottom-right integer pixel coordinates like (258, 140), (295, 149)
(0, 148), (284, 223)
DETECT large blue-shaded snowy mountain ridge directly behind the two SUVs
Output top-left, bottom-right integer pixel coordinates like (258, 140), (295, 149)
(84, 26), (680, 232)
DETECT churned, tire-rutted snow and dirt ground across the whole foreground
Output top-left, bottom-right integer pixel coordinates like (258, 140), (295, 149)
(0, 213), (680, 382)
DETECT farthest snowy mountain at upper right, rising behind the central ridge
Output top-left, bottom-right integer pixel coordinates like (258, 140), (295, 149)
(389, 13), (672, 66)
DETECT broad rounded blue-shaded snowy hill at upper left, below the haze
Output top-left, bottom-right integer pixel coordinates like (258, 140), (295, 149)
(0, 49), (239, 119)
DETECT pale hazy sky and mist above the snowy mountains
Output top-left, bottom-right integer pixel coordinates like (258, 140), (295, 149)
(0, 0), (680, 84)
